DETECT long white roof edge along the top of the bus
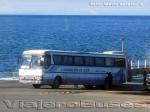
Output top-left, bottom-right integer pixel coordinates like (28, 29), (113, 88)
(23, 50), (126, 57)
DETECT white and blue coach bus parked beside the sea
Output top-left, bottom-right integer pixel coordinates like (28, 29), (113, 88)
(19, 50), (128, 88)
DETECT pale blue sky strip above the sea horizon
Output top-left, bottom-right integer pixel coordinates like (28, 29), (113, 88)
(0, 0), (150, 15)
